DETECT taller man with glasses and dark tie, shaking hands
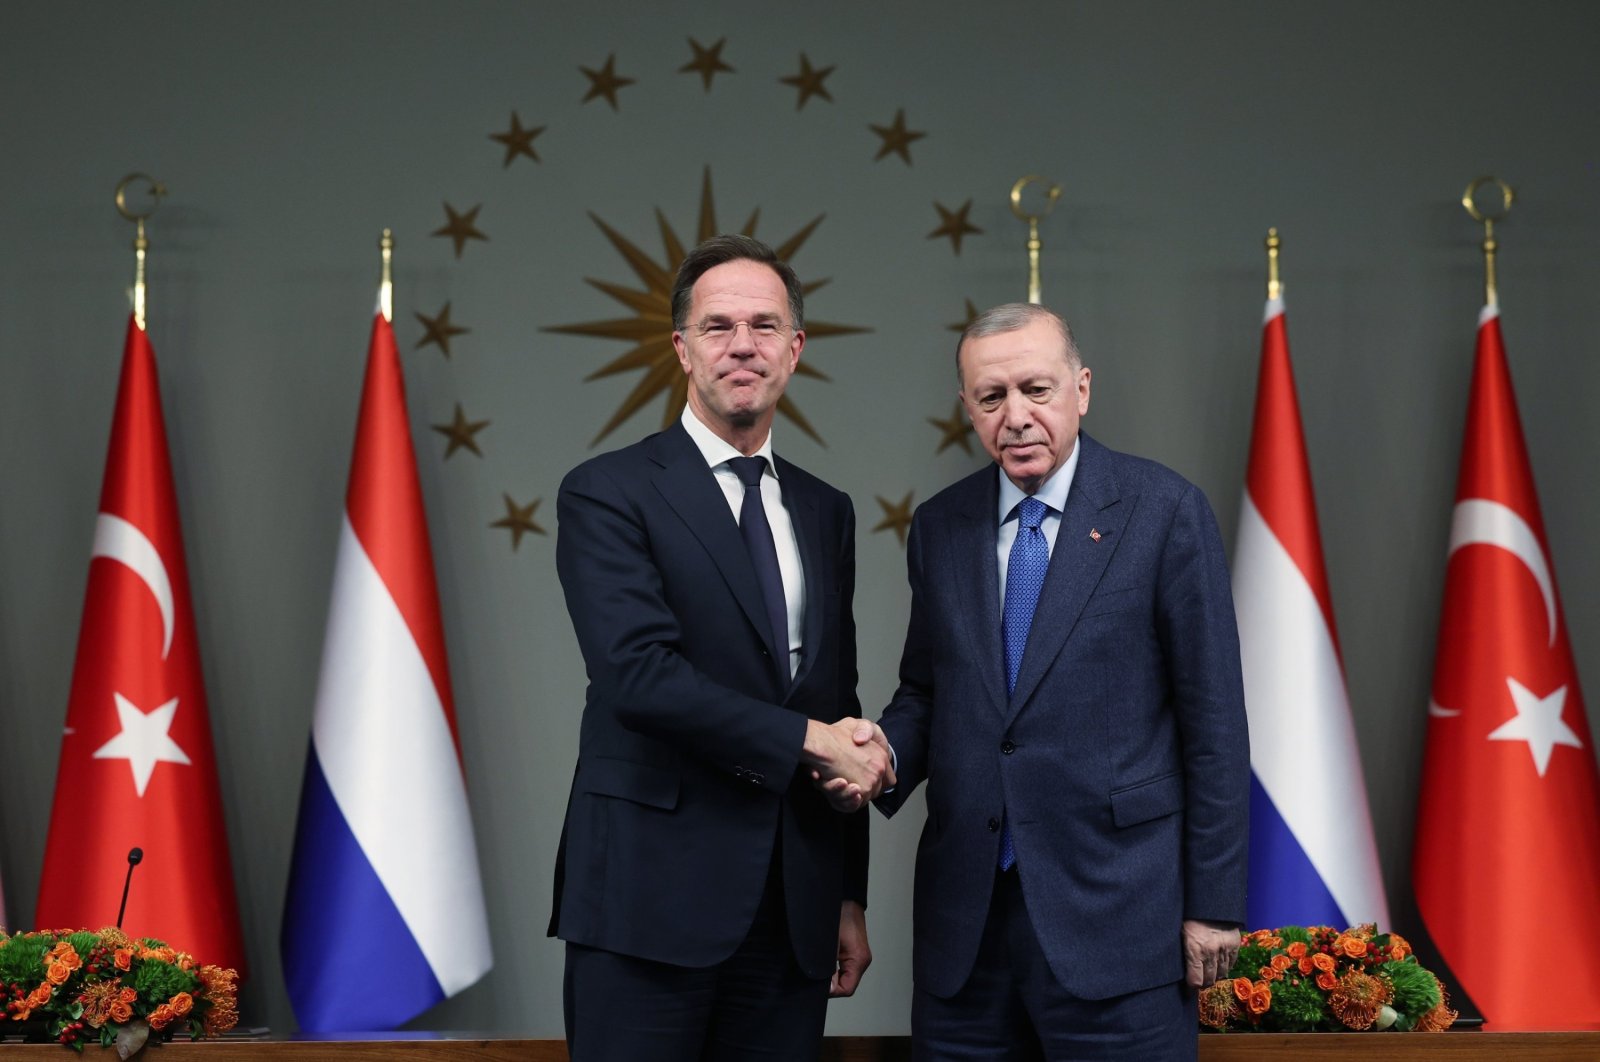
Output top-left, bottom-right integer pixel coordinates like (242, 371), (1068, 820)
(550, 237), (893, 1062)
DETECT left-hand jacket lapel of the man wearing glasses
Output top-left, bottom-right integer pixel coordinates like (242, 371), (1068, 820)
(650, 424), (789, 680)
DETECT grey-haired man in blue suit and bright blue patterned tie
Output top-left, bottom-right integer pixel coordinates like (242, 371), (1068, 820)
(864, 304), (1250, 1062)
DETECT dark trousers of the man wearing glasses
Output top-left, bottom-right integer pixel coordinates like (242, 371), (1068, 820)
(563, 859), (827, 1062)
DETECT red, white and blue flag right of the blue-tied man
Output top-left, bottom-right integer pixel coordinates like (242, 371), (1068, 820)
(1234, 299), (1389, 929)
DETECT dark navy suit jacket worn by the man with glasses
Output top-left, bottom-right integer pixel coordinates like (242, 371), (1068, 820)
(550, 424), (867, 977)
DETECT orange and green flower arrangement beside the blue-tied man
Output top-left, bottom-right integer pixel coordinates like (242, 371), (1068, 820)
(1200, 924), (1456, 1033)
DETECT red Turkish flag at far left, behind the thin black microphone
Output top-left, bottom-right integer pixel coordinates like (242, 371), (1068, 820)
(35, 318), (245, 972)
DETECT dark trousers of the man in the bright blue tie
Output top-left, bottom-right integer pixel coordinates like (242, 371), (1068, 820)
(910, 870), (1200, 1062)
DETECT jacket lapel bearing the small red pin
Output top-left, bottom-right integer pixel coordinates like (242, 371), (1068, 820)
(1011, 432), (1130, 723)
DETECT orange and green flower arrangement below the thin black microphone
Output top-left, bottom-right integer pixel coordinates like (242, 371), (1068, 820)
(0, 928), (238, 1057)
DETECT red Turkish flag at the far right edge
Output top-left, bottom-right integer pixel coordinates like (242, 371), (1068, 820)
(1411, 304), (1600, 1030)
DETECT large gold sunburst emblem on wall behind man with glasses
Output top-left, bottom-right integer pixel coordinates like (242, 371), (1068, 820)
(544, 166), (872, 446)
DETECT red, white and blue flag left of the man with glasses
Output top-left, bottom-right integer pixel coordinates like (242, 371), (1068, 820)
(282, 313), (493, 1032)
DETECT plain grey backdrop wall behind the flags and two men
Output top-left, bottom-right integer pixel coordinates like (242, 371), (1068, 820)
(0, 0), (1600, 1035)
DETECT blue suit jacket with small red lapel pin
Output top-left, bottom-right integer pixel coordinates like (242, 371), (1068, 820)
(878, 433), (1250, 1000)
